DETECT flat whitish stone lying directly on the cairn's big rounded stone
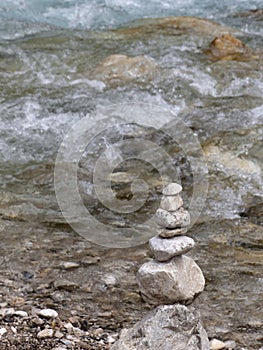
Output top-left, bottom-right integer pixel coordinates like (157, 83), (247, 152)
(149, 236), (195, 261)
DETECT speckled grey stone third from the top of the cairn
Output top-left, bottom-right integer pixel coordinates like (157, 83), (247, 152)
(156, 208), (191, 228)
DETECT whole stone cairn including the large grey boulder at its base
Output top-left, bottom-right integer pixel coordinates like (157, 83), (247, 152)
(111, 183), (210, 350)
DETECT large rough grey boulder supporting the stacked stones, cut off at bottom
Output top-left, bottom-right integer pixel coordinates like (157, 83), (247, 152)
(110, 304), (210, 350)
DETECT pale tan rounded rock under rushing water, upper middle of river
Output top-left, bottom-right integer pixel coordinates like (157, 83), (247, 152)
(89, 55), (158, 86)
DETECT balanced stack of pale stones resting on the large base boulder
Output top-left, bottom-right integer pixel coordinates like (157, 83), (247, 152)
(137, 183), (205, 305)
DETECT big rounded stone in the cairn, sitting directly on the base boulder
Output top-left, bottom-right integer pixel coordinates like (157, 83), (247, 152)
(137, 255), (205, 305)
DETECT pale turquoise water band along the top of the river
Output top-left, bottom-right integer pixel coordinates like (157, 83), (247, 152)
(0, 0), (262, 38)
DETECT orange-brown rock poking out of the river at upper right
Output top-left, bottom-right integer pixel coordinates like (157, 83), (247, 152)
(204, 34), (259, 61)
